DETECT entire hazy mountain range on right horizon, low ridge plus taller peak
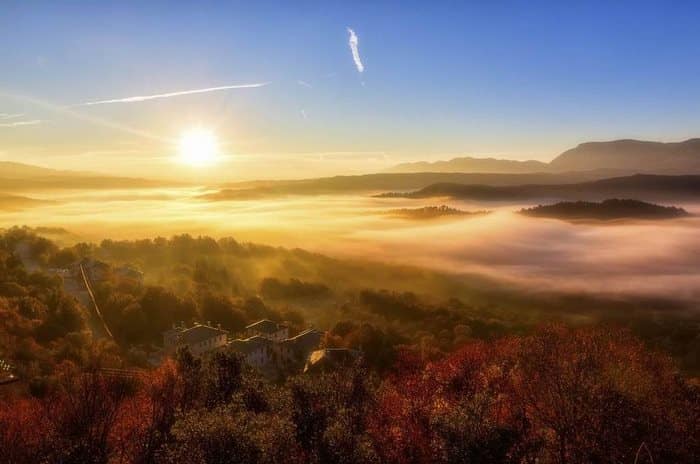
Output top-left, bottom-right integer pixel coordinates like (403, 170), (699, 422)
(389, 139), (700, 175)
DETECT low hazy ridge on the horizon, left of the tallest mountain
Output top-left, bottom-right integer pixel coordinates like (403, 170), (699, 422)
(388, 156), (549, 174)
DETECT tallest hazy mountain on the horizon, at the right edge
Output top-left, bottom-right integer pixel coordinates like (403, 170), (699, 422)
(549, 139), (700, 173)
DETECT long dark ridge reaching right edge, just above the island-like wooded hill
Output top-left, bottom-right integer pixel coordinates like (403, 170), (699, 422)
(378, 174), (700, 201)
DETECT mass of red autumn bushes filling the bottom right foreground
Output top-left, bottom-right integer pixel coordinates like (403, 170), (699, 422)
(370, 327), (700, 463)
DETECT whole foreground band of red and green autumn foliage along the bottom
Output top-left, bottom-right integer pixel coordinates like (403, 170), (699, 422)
(0, 327), (700, 463)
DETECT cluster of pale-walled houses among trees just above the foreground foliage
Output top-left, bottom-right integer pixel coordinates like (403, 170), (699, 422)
(163, 319), (360, 377)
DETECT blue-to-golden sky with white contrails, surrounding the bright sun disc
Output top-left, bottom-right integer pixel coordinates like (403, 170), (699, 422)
(0, 0), (700, 180)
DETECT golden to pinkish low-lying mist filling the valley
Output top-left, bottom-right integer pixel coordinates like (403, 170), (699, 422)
(5, 188), (700, 301)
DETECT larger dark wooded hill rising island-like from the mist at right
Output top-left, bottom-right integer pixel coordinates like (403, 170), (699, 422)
(520, 199), (688, 221)
